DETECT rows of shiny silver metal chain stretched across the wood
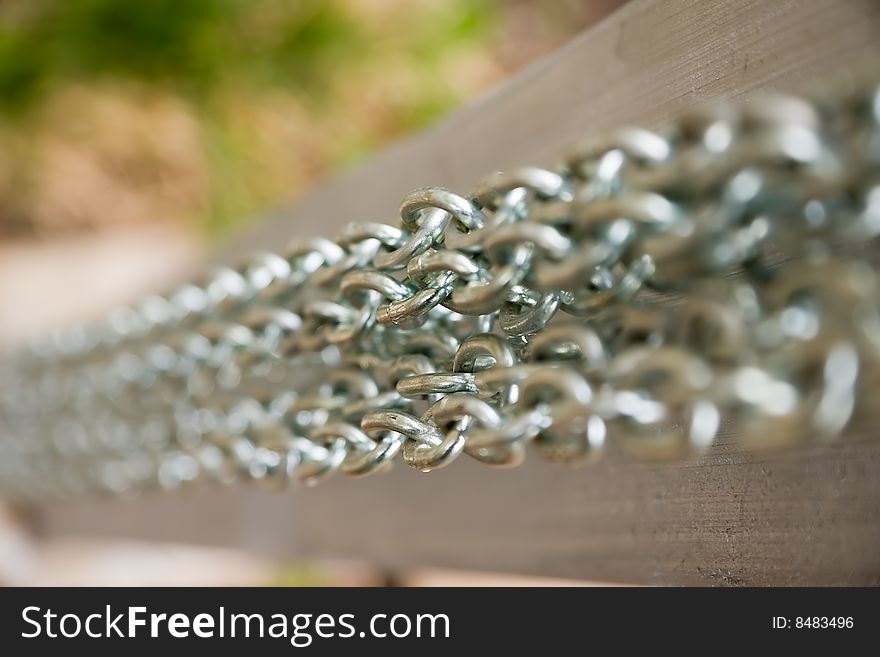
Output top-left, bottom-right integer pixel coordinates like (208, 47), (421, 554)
(0, 78), (880, 498)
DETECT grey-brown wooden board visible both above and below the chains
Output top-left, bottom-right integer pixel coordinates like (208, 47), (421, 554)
(34, 0), (880, 585)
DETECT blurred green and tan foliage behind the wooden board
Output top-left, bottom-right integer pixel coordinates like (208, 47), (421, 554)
(0, 0), (620, 239)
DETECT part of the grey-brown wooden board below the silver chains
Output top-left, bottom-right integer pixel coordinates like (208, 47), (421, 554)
(39, 430), (880, 585)
